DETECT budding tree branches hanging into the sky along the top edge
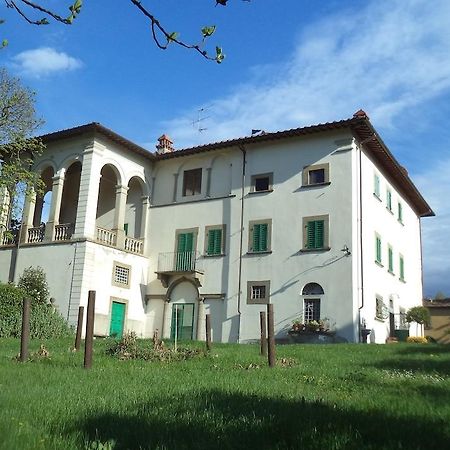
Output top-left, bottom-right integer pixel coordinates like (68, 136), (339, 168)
(3, 0), (251, 64)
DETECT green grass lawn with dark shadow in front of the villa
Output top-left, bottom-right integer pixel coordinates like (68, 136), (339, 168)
(0, 339), (450, 450)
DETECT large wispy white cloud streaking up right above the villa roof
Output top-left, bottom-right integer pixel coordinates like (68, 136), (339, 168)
(161, 0), (450, 148)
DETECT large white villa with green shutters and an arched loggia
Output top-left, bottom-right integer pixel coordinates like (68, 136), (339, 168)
(0, 111), (434, 343)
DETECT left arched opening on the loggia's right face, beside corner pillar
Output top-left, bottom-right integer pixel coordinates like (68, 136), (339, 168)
(96, 164), (120, 230)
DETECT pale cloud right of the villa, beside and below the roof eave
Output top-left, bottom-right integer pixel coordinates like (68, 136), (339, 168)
(414, 158), (450, 296)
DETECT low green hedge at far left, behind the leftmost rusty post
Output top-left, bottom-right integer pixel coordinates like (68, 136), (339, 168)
(0, 283), (72, 339)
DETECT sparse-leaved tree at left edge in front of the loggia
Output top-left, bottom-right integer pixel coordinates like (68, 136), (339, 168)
(0, 69), (44, 234)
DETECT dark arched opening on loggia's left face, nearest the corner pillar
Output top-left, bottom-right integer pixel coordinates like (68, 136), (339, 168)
(58, 161), (82, 226)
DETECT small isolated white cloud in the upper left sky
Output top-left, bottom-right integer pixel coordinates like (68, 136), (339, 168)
(12, 47), (83, 77)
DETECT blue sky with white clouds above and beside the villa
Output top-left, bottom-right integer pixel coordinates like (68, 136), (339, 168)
(0, 0), (450, 296)
